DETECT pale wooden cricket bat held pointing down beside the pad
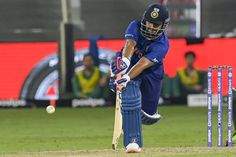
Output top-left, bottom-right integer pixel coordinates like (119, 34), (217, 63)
(112, 75), (122, 150)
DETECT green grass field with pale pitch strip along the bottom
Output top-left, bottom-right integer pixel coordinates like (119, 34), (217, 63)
(0, 106), (236, 157)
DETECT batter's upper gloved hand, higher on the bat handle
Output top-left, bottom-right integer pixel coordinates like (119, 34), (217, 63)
(111, 57), (130, 75)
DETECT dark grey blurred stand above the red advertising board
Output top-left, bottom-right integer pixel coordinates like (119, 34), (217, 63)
(0, 0), (236, 42)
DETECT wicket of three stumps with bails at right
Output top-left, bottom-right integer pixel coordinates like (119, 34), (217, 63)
(207, 66), (233, 147)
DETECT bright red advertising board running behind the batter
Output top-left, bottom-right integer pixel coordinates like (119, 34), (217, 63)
(0, 38), (236, 100)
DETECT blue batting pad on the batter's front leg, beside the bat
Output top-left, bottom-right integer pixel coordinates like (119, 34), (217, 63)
(121, 81), (143, 147)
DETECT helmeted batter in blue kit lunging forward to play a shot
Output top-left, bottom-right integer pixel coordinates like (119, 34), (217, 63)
(109, 4), (170, 153)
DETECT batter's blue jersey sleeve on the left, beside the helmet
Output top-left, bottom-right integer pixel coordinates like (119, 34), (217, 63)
(125, 20), (139, 42)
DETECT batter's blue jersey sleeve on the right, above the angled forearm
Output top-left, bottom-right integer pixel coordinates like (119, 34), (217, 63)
(145, 42), (169, 64)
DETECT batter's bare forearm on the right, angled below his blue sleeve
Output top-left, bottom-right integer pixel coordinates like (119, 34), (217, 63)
(128, 57), (154, 79)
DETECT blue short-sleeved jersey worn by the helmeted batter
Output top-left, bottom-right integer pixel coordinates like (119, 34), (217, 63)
(125, 20), (169, 79)
